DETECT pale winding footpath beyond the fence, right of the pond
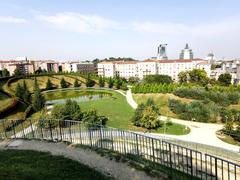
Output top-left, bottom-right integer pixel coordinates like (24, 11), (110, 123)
(126, 89), (240, 152)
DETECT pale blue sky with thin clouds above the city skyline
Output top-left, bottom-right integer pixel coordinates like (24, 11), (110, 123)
(0, 0), (240, 60)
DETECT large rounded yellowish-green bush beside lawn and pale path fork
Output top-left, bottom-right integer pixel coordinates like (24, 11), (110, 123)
(132, 99), (161, 129)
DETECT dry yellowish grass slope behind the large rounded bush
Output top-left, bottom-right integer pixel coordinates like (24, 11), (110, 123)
(133, 93), (194, 118)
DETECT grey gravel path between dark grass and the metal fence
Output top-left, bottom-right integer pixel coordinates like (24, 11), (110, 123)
(0, 140), (162, 180)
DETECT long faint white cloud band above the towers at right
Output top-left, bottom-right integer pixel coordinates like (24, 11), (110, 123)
(132, 17), (240, 37)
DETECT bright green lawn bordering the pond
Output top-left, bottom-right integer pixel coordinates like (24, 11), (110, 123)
(40, 89), (190, 135)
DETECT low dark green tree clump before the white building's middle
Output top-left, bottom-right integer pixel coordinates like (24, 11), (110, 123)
(143, 74), (173, 84)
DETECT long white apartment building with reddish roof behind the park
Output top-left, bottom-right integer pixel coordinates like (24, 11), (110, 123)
(98, 59), (211, 81)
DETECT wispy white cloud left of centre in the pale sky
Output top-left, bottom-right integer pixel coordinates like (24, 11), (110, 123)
(37, 12), (120, 34)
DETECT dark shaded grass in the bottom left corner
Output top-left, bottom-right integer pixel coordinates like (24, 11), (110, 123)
(0, 150), (110, 180)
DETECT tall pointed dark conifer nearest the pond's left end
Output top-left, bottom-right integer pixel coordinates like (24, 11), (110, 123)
(32, 79), (45, 111)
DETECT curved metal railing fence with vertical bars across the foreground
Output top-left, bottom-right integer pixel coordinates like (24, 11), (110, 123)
(0, 120), (240, 180)
